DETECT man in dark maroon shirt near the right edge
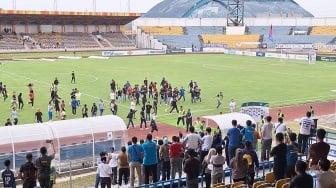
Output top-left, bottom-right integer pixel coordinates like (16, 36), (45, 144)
(307, 129), (330, 169)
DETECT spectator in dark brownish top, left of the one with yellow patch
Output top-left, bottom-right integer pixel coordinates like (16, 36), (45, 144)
(230, 148), (248, 182)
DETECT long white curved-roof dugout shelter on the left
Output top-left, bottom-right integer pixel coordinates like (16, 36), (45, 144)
(0, 115), (127, 172)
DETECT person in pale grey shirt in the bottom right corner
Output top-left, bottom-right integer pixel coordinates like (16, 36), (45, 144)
(316, 159), (336, 188)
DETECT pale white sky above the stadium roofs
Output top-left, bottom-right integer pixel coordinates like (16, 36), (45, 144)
(0, 0), (336, 17)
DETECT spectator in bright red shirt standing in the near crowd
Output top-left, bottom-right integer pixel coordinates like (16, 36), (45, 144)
(169, 136), (183, 179)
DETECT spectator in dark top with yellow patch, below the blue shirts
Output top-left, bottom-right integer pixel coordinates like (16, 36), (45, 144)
(243, 141), (259, 186)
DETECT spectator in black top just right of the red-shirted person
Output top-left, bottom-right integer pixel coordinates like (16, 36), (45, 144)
(183, 149), (201, 188)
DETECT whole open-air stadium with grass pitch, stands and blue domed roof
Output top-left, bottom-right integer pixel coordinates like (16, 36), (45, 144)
(0, 0), (336, 188)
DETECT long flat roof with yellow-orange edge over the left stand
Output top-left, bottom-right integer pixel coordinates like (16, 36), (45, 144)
(0, 10), (141, 25)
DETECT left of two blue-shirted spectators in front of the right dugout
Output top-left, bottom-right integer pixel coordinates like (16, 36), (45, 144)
(227, 120), (240, 161)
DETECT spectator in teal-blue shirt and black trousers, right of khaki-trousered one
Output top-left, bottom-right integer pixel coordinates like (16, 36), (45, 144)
(142, 134), (158, 184)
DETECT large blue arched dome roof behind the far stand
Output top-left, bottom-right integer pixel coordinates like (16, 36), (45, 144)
(143, 0), (313, 18)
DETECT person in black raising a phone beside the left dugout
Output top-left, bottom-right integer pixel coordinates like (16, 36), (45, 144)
(35, 141), (56, 188)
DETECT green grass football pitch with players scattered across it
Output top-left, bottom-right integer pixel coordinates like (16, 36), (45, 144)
(0, 53), (336, 125)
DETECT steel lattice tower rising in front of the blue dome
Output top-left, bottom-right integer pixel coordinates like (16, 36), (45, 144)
(227, 0), (244, 26)
